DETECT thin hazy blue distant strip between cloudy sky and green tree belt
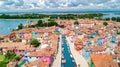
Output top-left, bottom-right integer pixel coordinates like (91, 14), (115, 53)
(0, 10), (120, 14)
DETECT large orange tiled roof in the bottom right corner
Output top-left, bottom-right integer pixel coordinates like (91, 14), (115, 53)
(90, 54), (119, 67)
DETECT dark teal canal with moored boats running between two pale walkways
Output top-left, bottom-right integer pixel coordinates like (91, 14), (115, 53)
(61, 35), (75, 67)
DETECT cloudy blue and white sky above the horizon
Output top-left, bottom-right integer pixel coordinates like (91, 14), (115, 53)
(0, 0), (120, 12)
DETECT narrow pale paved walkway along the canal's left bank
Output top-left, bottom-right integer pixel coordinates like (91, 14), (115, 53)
(52, 35), (62, 67)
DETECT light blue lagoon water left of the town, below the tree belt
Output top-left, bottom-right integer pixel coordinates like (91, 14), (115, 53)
(0, 19), (37, 35)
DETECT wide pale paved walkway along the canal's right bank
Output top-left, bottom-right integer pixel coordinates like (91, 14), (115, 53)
(66, 37), (89, 67)
